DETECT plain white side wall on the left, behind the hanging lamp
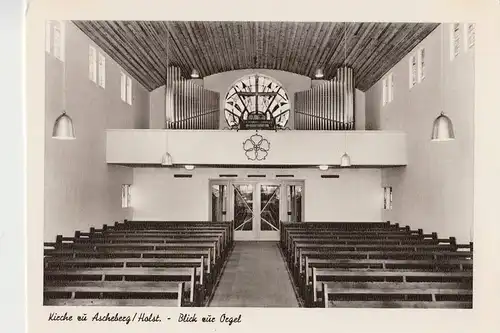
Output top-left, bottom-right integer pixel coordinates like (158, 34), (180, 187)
(44, 22), (149, 241)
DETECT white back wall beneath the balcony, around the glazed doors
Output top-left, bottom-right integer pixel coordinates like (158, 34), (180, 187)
(131, 168), (383, 222)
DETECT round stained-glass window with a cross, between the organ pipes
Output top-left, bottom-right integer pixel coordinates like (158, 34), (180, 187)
(224, 74), (290, 128)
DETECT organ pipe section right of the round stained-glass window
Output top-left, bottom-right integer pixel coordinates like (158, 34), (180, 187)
(294, 67), (355, 130)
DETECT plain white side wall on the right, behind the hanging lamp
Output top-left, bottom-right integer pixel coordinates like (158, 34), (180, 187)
(366, 25), (474, 242)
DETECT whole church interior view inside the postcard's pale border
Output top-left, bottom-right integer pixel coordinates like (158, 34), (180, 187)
(43, 21), (475, 309)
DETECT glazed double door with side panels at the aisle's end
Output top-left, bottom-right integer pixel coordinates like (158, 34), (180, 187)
(210, 180), (304, 240)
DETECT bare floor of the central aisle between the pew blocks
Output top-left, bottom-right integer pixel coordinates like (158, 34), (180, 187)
(210, 242), (299, 307)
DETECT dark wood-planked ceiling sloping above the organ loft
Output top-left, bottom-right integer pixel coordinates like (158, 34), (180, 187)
(74, 21), (438, 91)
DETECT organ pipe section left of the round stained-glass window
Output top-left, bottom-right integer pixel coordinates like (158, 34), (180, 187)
(165, 67), (220, 129)
